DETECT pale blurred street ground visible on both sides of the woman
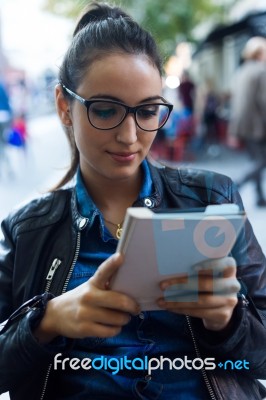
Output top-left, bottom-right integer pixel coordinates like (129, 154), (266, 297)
(0, 114), (266, 400)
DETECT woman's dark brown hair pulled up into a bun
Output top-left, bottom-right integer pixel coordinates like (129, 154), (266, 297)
(55, 2), (162, 189)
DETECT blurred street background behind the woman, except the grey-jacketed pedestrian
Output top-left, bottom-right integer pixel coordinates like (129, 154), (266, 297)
(0, 0), (266, 400)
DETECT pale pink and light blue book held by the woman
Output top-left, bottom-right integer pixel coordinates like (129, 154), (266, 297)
(110, 204), (246, 311)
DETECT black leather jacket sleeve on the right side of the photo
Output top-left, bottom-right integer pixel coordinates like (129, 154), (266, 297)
(192, 180), (266, 379)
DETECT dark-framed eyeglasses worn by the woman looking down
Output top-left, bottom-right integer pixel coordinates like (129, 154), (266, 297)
(61, 83), (173, 132)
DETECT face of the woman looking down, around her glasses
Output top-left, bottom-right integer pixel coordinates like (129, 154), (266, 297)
(66, 54), (162, 180)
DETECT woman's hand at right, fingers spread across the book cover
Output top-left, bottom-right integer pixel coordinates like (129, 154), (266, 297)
(158, 257), (240, 331)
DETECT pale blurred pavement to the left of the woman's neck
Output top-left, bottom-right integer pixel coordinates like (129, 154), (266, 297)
(0, 114), (70, 225)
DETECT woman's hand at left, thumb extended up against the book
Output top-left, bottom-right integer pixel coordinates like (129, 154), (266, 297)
(34, 253), (140, 343)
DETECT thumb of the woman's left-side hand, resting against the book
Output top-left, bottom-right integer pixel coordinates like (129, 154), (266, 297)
(90, 253), (123, 290)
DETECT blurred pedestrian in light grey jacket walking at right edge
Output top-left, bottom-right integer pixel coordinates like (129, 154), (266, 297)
(228, 36), (266, 207)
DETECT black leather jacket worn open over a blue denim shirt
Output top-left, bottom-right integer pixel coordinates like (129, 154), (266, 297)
(0, 165), (266, 400)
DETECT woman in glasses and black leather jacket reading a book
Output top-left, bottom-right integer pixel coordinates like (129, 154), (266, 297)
(0, 3), (266, 400)
